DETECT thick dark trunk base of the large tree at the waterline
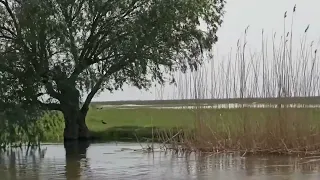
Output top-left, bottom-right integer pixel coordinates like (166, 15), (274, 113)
(62, 107), (90, 140)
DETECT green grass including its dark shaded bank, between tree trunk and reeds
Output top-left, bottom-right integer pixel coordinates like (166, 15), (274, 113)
(86, 108), (194, 141)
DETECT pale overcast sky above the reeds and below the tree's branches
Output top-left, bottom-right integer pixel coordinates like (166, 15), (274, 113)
(90, 0), (320, 101)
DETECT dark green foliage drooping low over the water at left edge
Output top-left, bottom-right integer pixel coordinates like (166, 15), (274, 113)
(0, 80), (43, 147)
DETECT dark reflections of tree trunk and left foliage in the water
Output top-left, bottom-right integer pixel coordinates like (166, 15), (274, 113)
(0, 142), (90, 180)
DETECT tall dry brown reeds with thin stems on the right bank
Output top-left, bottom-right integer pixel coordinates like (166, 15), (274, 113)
(159, 4), (320, 155)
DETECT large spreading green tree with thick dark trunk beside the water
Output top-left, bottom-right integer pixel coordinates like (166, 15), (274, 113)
(0, 0), (225, 139)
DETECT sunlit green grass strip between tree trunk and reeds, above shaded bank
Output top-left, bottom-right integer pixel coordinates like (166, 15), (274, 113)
(87, 108), (194, 131)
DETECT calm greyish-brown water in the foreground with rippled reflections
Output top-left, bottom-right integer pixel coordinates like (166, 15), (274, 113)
(0, 143), (320, 180)
